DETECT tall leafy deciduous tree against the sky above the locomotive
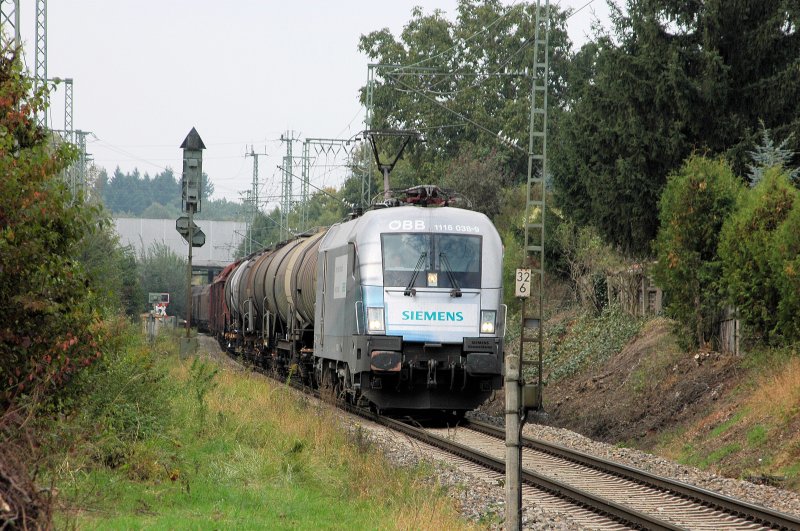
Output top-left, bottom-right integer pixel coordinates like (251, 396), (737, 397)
(359, 0), (571, 184)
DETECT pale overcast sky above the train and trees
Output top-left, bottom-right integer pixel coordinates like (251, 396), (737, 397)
(12, 0), (607, 205)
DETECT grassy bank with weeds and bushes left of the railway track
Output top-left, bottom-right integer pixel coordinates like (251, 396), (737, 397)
(54, 328), (476, 529)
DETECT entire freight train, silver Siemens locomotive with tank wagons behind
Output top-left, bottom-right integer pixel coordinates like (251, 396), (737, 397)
(200, 198), (506, 414)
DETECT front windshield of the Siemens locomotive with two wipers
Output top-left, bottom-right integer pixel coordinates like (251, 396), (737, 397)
(381, 233), (481, 288)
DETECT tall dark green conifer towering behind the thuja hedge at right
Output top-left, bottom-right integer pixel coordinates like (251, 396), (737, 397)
(551, 0), (800, 255)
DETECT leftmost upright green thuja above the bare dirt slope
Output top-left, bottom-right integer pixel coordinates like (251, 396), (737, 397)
(653, 155), (743, 346)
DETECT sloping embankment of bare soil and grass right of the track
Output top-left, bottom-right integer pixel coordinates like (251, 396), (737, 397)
(545, 311), (800, 491)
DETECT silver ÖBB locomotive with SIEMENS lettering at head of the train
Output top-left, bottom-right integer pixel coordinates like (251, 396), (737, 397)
(314, 206), (505, 413)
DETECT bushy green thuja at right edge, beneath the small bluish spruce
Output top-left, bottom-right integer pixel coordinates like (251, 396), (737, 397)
(719, 167), (800, 341)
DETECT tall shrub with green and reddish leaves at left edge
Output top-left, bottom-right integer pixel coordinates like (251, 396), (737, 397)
(0, 49), (100, 411)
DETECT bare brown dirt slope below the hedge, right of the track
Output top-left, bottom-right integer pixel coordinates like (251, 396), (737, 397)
(542, 318), (739, 447)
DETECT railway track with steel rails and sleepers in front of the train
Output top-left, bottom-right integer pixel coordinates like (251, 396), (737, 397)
(214, 342), (800, 531)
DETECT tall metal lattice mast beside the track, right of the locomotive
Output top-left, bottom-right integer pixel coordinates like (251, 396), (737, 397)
(520, 0), (550, 409)
